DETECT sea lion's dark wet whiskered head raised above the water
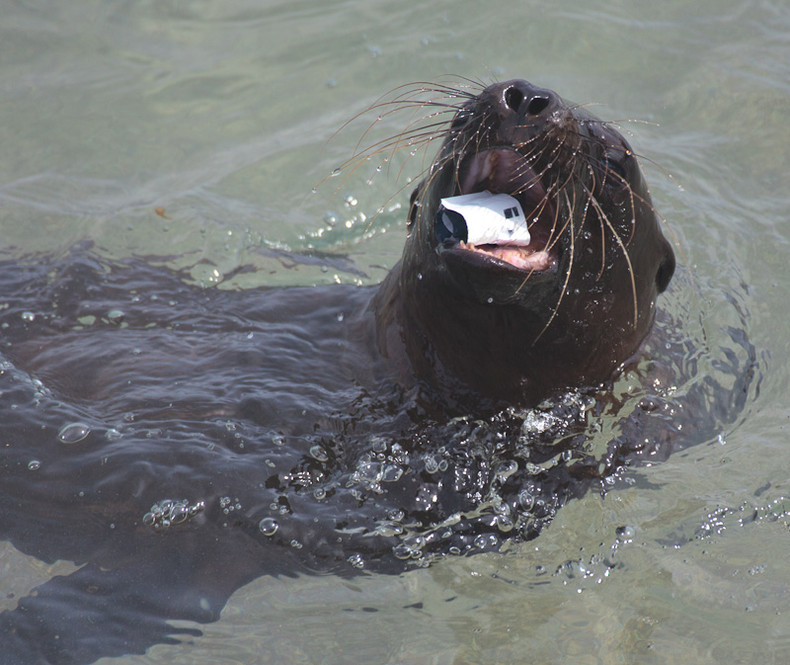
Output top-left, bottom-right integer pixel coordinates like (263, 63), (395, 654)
(383, 80), (675, 402)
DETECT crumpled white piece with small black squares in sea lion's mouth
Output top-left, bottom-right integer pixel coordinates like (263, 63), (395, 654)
(441, 191), (530, 245)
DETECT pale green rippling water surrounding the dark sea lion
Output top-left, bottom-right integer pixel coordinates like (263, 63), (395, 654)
(0, 0), (790, 665)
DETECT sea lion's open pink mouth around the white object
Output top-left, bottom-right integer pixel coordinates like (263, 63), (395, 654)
(436, 147), (559, 272)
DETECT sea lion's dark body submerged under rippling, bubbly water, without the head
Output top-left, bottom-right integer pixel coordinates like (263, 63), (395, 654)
(0, 247), (759, 663)
